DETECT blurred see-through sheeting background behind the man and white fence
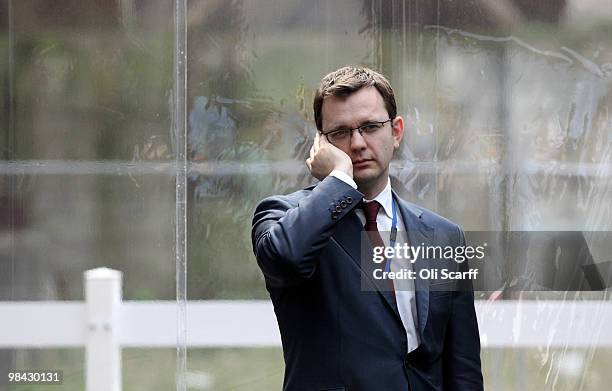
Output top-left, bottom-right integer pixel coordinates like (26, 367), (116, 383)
(0, 0), (612, 390)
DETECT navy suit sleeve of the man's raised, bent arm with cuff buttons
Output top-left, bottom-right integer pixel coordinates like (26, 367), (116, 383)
(251, 176), (363, 286)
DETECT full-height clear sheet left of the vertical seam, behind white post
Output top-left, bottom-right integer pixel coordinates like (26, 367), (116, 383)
(0, 0), (176, 390)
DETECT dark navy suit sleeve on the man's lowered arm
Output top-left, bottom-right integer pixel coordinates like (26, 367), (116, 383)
(444, 227), (483, 391)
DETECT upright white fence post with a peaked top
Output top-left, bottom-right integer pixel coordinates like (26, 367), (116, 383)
(85, 267), (122, 391)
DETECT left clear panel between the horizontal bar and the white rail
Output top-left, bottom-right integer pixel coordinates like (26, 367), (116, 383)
(0, 174), (175, 300)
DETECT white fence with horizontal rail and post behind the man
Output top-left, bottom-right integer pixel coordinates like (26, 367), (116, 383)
(0, 268), (612, 391)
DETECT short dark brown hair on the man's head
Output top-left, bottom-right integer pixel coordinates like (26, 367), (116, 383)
(313, 66), (397, 131)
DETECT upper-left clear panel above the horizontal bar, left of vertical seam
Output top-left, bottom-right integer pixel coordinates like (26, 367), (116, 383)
(3, 0), (173, 161)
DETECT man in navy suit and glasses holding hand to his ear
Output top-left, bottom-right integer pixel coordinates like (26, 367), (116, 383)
(252, 67), (483, 391)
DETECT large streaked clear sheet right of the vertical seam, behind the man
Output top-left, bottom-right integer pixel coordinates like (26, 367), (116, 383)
(187, 0), (612, 390)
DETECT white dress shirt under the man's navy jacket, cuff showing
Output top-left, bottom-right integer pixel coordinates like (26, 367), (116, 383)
(330, 170), (419, 352)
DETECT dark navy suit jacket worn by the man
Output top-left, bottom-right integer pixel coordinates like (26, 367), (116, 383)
(252, 176), (483, 391)
